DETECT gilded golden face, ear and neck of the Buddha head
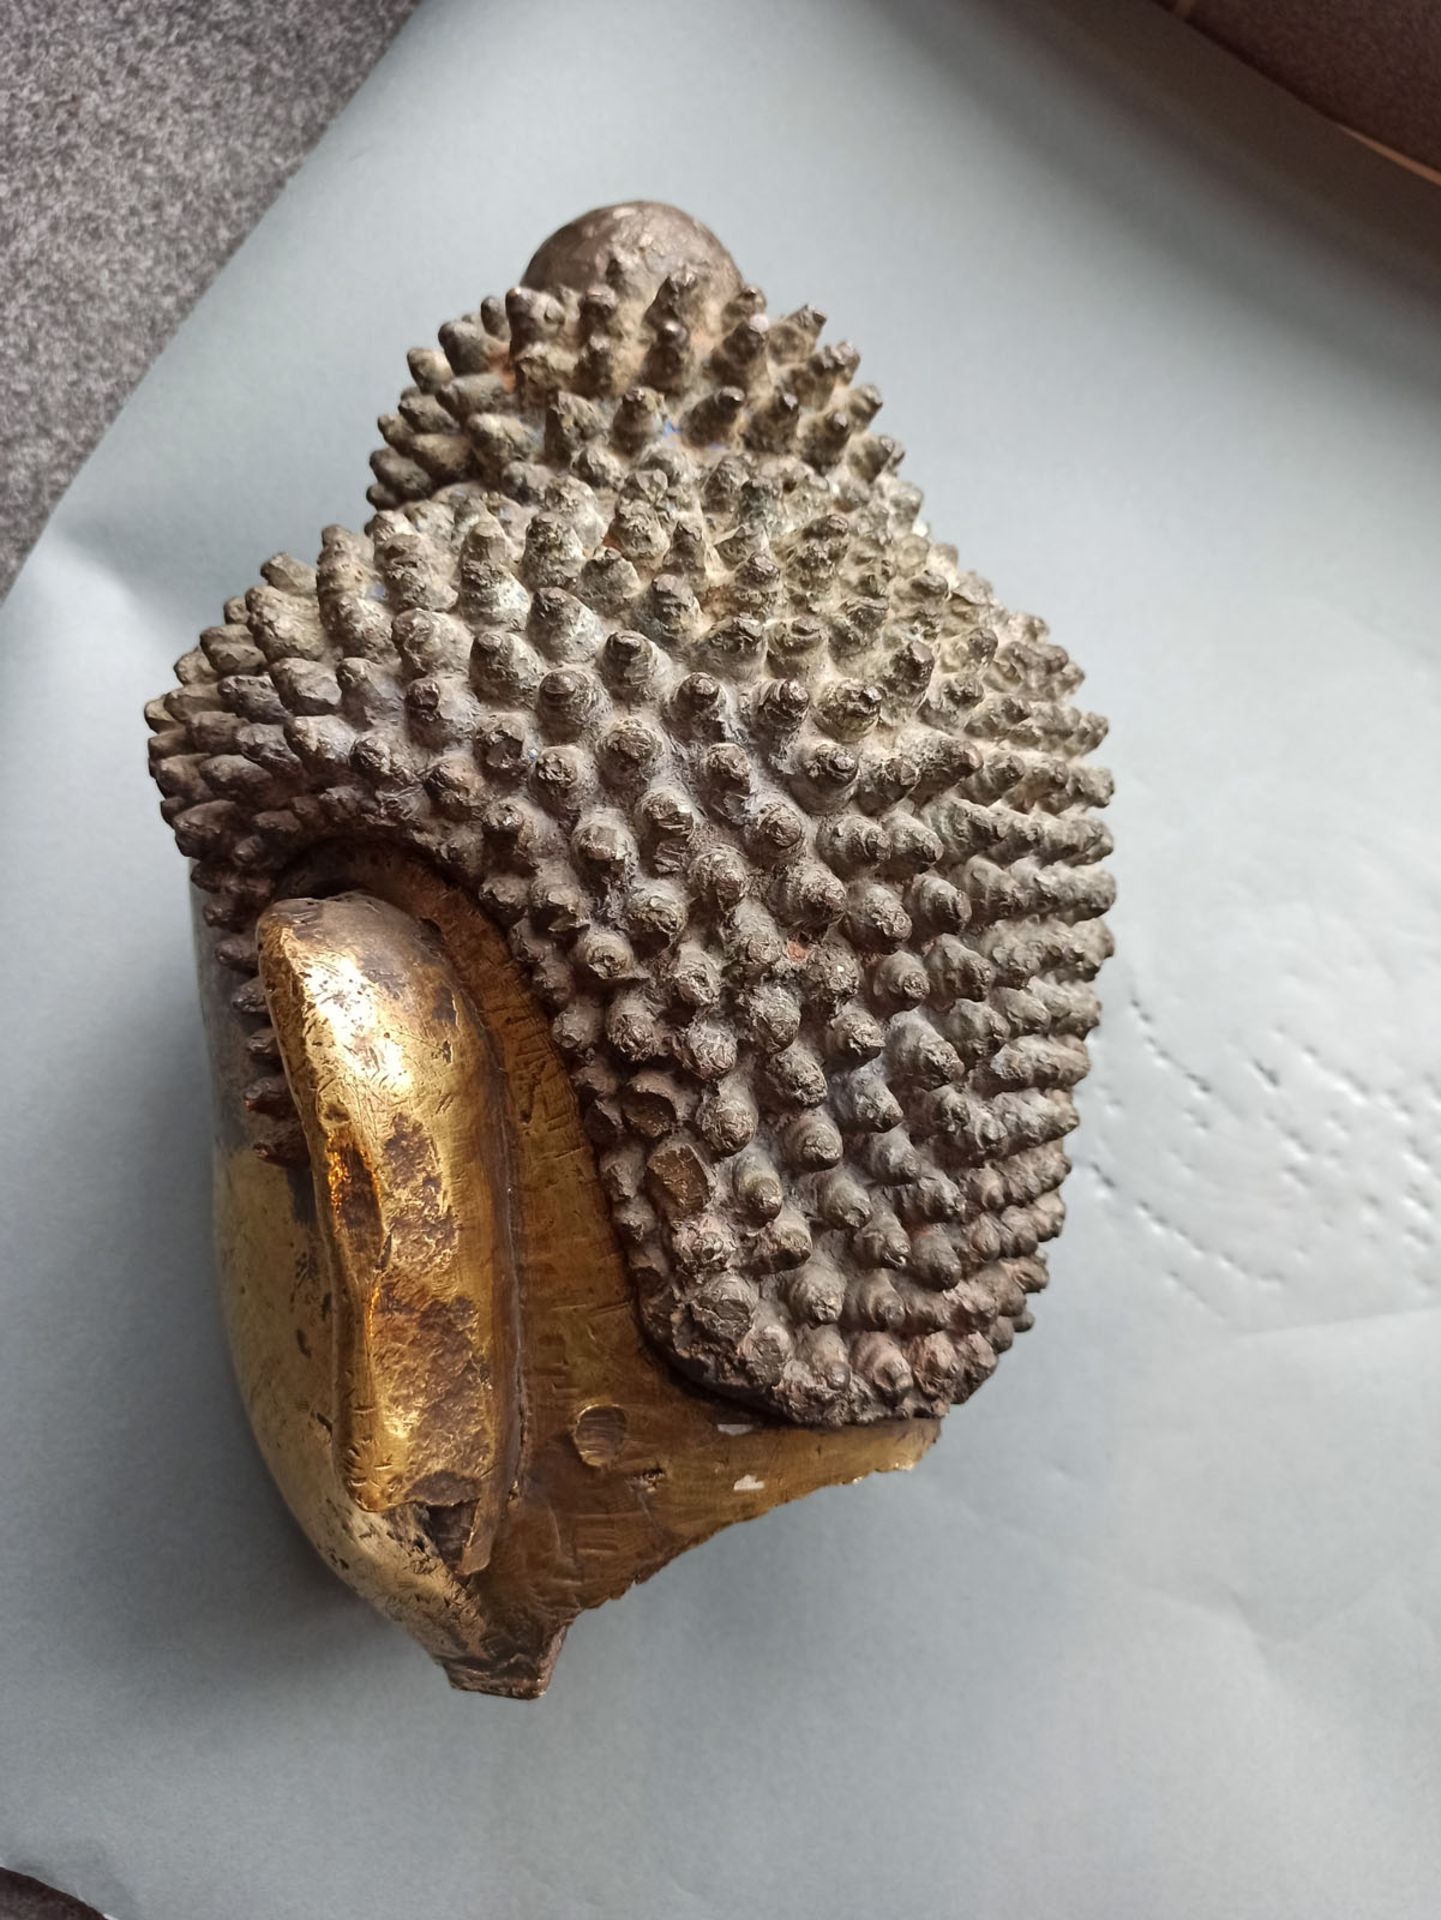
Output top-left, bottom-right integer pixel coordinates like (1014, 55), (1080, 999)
(211, 852), (936, 1695)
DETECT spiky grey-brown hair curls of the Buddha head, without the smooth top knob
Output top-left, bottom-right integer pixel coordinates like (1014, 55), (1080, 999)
(150, 257), (1113, 1425)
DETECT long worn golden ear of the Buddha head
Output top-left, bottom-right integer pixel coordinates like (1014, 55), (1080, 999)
(259, 893), (520, 1572)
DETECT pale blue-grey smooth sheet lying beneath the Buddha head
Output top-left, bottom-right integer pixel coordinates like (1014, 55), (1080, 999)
(0, 0), (1441, 1920)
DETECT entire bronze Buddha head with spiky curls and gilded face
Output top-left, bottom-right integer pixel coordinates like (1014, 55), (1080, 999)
(150, 204), (1111, 1695)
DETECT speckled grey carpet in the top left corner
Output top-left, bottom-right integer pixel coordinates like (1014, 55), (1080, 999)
(0, 0), (416, 593)
